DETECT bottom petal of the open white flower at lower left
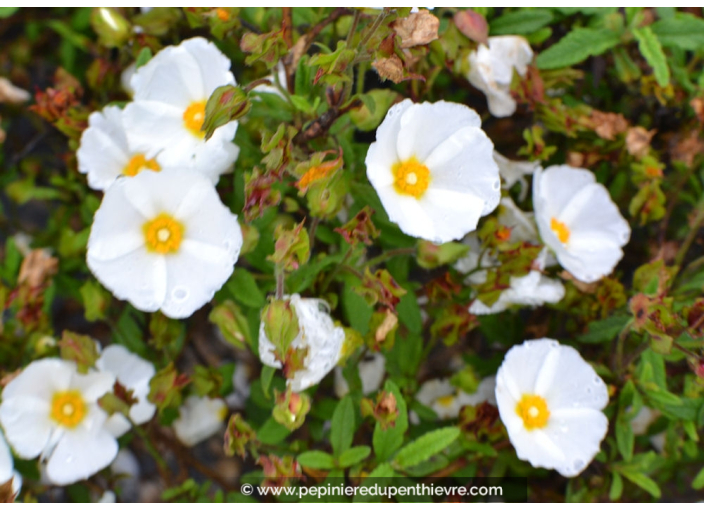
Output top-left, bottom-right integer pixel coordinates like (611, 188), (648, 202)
(46, 427), (118, 485)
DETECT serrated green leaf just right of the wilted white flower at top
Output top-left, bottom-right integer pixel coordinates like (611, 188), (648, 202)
(535, 28), (620, 69)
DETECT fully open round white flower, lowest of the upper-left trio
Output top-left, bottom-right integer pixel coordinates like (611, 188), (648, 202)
(87, 169), (242, 318)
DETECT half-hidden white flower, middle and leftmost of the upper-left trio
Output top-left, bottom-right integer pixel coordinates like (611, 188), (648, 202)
(76, 106), (161, 190)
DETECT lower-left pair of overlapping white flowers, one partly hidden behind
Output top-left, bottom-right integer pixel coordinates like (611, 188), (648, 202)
(0, 345), (156, 485)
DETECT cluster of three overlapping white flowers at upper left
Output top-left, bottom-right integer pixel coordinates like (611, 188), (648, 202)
(77, 38), (242, 318)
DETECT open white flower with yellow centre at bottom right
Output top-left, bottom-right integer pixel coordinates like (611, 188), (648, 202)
(496, 338), (609, 477)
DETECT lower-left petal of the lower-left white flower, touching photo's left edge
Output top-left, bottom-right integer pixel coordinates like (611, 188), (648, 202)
(0, 395), (54, 459)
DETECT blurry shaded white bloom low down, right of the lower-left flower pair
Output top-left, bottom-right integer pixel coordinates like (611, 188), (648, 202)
(172, 395), (227, 446)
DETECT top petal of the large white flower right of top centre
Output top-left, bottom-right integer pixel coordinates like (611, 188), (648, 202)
(396, 101), (482, 162)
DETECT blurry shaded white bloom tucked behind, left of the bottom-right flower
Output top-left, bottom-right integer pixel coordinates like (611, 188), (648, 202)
(416, 376), (496, 420)
